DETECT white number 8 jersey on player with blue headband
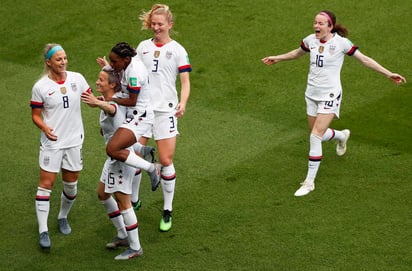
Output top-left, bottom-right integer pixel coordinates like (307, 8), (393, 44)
(30, 71), (91, 149)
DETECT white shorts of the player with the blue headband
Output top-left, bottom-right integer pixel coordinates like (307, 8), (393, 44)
(39, 145), (83, 173)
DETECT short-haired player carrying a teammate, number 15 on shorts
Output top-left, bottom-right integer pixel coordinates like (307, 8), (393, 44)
(82, 66), (143, 260)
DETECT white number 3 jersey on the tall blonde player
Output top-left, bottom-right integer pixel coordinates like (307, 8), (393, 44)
(137, 39), (192, 112)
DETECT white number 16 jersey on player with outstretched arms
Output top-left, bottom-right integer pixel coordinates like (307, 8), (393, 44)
(301, 33), (358, 101)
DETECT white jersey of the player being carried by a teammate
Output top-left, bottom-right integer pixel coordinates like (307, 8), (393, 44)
(120, 57), (150, 117)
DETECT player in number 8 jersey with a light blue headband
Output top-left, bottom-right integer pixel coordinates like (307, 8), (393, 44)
(30, 44), (91, 249)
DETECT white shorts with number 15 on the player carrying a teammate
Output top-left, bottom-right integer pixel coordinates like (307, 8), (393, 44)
(100, 157), (136, 195)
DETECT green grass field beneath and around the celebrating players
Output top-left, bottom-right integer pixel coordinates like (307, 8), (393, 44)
(0, 0), (412, 271)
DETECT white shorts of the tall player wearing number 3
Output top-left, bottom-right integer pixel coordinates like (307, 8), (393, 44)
(144, 111), (179, 140)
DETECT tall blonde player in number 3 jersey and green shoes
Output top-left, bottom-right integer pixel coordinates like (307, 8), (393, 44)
(133, 4), (192, 231)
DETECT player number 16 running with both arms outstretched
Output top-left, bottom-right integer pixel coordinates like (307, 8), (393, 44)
(262, 10), (406, 196)
